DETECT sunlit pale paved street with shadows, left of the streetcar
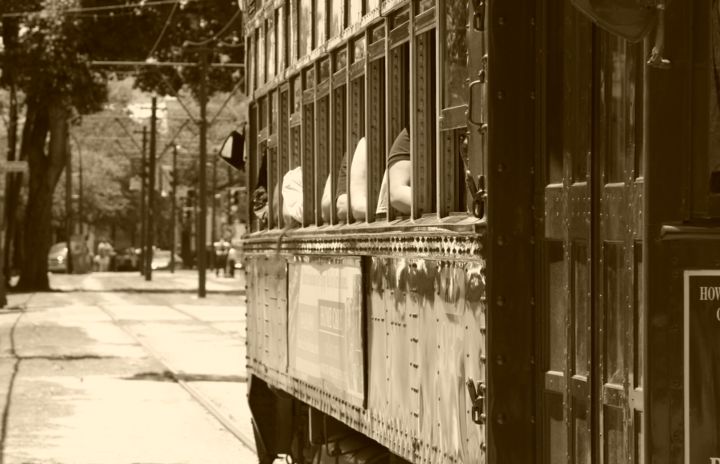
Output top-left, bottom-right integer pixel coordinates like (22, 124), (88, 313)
(0, 271), (257, 464)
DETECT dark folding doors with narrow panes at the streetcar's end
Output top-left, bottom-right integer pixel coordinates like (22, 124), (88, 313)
(536, 0), (645, 464)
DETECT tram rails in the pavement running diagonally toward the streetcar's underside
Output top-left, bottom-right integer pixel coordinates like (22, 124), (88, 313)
(93, 294), (257, 453)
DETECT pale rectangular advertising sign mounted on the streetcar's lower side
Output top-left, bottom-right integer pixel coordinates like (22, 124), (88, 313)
(288, 258), (364, 406)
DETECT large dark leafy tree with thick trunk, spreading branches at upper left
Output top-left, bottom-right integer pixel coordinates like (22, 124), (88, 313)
(0, 0), (242, 291)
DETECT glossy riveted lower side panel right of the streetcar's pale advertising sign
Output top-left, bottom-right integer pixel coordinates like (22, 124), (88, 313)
(368, 258), (486, 463)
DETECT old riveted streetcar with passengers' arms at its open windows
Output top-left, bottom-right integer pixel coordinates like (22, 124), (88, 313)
(222, 0), (720, 464)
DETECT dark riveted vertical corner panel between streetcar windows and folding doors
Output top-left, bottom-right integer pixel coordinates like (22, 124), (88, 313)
(486, 1), (536, 464)
